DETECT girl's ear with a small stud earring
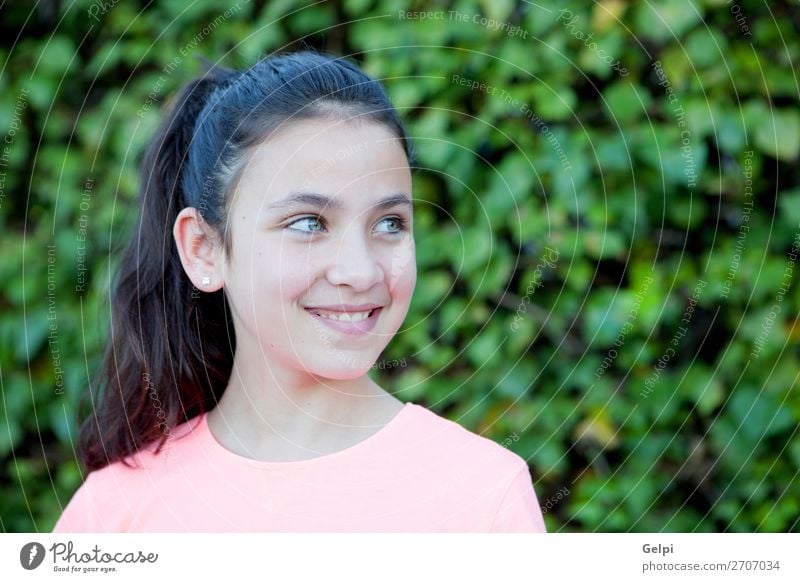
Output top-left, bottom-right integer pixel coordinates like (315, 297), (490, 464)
(172, 207), (224, 293)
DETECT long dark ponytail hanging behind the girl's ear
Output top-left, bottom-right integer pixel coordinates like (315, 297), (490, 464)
(78, 62), (235, 472)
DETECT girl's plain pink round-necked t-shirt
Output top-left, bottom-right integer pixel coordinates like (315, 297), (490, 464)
(53, 402), (546, 532)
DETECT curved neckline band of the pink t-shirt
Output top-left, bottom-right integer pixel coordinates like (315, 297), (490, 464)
(194, 402), (416, 470)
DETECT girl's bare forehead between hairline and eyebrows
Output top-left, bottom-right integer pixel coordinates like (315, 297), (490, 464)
(230, 119), (411, 210)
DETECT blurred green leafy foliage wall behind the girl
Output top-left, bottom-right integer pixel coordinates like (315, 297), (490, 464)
(0, 0), (800, 532)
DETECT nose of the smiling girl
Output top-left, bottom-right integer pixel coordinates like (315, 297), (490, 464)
(327, 226), (384, 292)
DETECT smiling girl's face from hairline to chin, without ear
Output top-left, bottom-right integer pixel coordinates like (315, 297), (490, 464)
(223, 120), (417, 379)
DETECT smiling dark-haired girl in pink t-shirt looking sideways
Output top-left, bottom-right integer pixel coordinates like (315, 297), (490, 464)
(54, 52), (545, 532)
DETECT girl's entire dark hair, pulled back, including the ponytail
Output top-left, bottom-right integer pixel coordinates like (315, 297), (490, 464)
(78, 51), (413, 471)
